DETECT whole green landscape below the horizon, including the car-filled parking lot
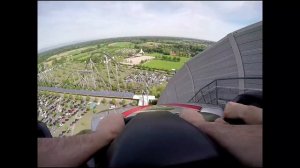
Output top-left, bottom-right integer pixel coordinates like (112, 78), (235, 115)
(37, 37), (213, 137)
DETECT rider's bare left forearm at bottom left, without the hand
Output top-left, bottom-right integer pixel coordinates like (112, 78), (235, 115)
(38, 133), (111, 167)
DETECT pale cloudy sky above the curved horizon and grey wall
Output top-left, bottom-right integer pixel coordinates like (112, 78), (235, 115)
(38, 1), (262, 50)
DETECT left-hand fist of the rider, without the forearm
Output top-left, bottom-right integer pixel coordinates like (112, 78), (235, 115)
(95, 112), (125, 143)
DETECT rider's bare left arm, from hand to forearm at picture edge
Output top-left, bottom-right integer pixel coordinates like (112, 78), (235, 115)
(38, 113), (125, 167)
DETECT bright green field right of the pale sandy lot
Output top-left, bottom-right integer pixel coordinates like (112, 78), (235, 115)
(143, 57), (190, 70)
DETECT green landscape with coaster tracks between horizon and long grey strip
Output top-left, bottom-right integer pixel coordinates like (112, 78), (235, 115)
(38, 37), (212, 94)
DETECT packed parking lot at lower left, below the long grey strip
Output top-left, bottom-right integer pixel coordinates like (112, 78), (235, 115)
(38, 93), (135, 137)
